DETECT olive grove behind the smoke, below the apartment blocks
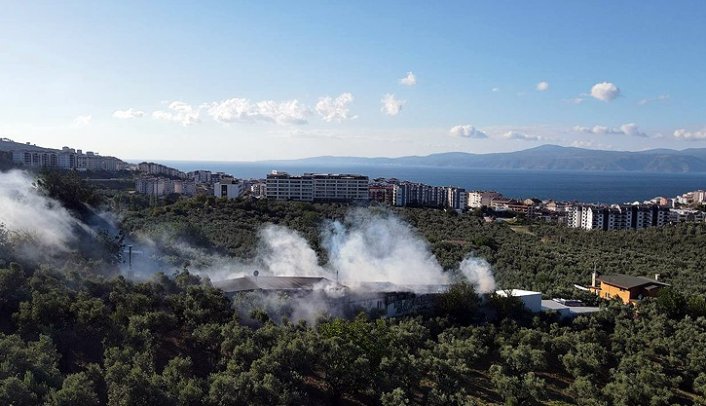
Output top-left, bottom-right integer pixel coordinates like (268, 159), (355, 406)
(122, 197), (706, 296)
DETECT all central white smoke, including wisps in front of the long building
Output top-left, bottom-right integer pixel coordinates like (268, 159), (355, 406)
(122, 209), (495, 323)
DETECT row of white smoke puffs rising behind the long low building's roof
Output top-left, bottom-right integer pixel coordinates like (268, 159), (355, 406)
(133, 208), (495, 293)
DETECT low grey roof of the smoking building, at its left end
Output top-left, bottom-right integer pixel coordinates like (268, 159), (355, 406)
(213, 276), (337, 292)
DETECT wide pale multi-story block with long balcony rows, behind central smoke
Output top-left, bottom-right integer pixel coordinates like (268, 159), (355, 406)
(266, 171), (369, 201)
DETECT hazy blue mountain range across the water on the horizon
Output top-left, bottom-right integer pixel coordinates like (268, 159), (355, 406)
(267, 145), (706, 173)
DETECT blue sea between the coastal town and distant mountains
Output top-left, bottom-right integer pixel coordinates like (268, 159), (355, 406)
(160, 161), (706, 204)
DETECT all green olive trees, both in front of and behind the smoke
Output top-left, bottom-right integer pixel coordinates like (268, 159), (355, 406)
(0, 178), (706, 406)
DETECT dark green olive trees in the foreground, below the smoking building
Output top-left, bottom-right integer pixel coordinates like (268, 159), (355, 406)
(0, 265), (706, 405)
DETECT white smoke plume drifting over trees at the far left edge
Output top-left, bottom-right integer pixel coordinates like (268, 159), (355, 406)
(0, 170), (87, 255)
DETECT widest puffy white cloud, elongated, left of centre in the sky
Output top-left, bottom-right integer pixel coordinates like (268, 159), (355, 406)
(207, 98), (311, 125)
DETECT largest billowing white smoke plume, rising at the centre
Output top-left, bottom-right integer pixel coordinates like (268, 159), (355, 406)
(322, 209), (448, 286)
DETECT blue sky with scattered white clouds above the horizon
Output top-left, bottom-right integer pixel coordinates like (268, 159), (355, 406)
(0, 0), (706, 161)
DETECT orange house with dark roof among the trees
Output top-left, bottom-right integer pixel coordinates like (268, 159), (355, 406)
(591, 274), (669, 304)
